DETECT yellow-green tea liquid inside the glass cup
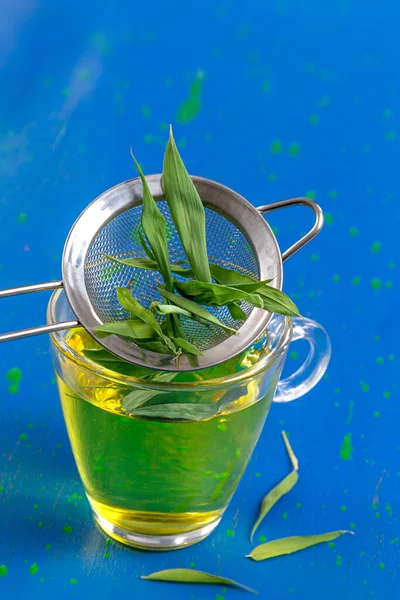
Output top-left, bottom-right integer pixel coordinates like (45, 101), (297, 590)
(57, 330), (274, 535)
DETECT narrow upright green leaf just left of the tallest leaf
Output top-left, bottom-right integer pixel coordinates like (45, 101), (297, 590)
(131, 151), (172, 290)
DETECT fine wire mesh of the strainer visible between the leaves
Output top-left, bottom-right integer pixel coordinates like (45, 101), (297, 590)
(85, 200), (259, 351)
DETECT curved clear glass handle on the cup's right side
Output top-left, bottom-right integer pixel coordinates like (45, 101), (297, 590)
(274, 317), (331, 402)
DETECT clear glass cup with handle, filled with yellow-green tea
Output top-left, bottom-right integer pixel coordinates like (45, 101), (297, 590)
(47, 290), (331, 550)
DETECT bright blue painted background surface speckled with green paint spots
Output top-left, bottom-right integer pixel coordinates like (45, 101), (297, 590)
(0, 0), (400, 600)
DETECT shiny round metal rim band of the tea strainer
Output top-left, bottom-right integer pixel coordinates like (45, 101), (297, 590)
(62, 174), (283, 371)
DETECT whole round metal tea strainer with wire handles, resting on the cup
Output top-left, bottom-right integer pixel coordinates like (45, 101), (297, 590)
(0, 175), (323, 371)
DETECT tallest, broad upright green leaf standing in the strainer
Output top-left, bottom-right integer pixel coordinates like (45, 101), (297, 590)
(162, 127), (211, 283)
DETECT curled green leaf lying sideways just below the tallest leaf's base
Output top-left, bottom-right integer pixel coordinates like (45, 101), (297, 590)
(174, 281), (263, 308)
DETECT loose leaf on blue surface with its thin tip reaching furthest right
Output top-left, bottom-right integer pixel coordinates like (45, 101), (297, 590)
(247, 530), (353, 561)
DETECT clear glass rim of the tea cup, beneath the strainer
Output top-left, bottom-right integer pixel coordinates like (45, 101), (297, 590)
(46, 289), (293, 390)
